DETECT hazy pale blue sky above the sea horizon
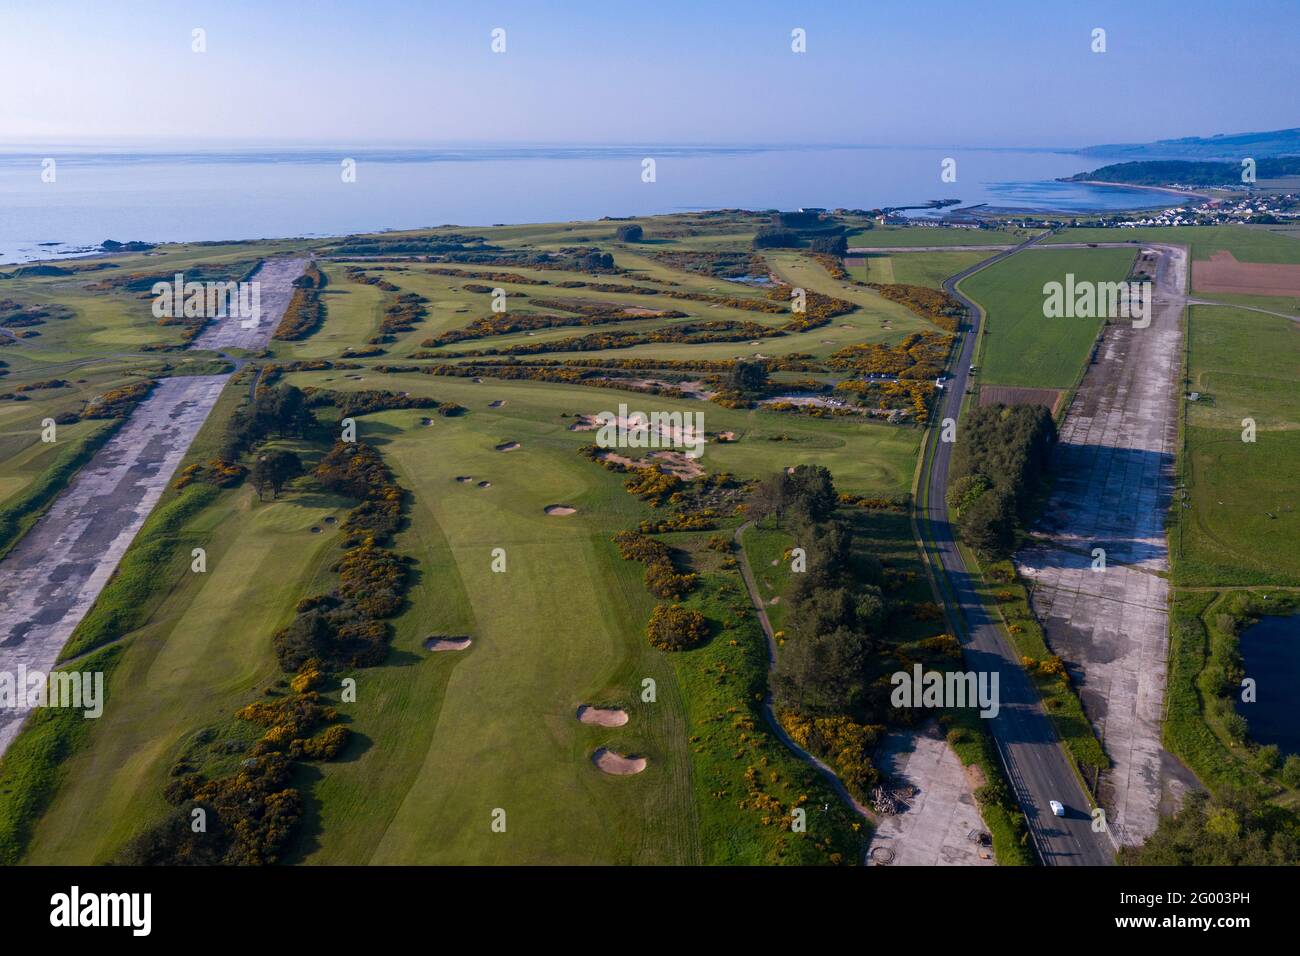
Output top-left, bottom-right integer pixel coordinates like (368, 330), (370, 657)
(0, 0), (1300, 146)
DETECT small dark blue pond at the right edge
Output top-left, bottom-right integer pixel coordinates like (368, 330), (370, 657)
(1236, 614), (1300, 754)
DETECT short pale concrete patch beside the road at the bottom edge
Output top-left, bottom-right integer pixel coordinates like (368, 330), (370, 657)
(868, 731), (995, 866)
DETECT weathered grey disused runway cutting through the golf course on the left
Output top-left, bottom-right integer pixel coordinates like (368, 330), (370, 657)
(0, 259), (306, 754)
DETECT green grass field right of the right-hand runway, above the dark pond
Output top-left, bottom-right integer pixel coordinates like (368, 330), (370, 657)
(1170, 306), (1300, 587)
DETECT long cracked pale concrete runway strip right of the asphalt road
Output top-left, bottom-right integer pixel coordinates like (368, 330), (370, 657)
(1017, 246), (1187, 844)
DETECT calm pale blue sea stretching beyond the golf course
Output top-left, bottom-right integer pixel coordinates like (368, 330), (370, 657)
(0, 141), (1161, 263)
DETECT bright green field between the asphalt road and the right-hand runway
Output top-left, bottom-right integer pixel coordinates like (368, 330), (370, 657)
(962, 248), (1135, 389)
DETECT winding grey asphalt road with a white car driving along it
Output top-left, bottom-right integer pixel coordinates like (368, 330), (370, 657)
(923, 237), (1115, 866)
